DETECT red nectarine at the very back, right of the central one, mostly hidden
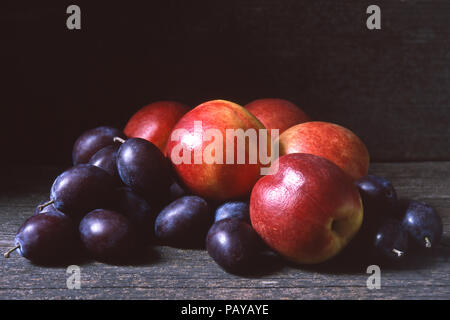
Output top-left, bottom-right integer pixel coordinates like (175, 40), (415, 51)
(245, 99), (310, 134)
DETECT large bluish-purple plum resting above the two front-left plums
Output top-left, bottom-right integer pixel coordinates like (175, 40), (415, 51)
(50, 164), (114, 219)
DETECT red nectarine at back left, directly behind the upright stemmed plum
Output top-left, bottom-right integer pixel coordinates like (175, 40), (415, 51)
(124, 101), (189, 152)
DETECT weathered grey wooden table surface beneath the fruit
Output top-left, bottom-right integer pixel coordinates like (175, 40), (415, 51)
(0, 161), (450, 299)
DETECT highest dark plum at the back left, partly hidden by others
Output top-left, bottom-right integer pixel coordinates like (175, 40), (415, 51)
(72, 127), (125, 165)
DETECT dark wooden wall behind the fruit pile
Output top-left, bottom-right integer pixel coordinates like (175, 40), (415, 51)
(0, 0), (450, 164)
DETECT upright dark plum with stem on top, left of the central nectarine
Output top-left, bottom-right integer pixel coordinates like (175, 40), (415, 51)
(117, 138), (172, 202)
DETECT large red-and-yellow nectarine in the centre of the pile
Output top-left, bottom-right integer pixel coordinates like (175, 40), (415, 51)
(166, 100), (270, 200)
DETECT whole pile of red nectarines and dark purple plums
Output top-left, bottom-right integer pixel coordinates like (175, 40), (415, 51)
(5, 99), (442, 273)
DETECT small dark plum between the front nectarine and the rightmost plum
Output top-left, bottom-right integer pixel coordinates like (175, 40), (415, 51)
(374, 219), (408, 261)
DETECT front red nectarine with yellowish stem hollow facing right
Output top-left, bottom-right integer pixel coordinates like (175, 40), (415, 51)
(250, 153), (363, 264)
